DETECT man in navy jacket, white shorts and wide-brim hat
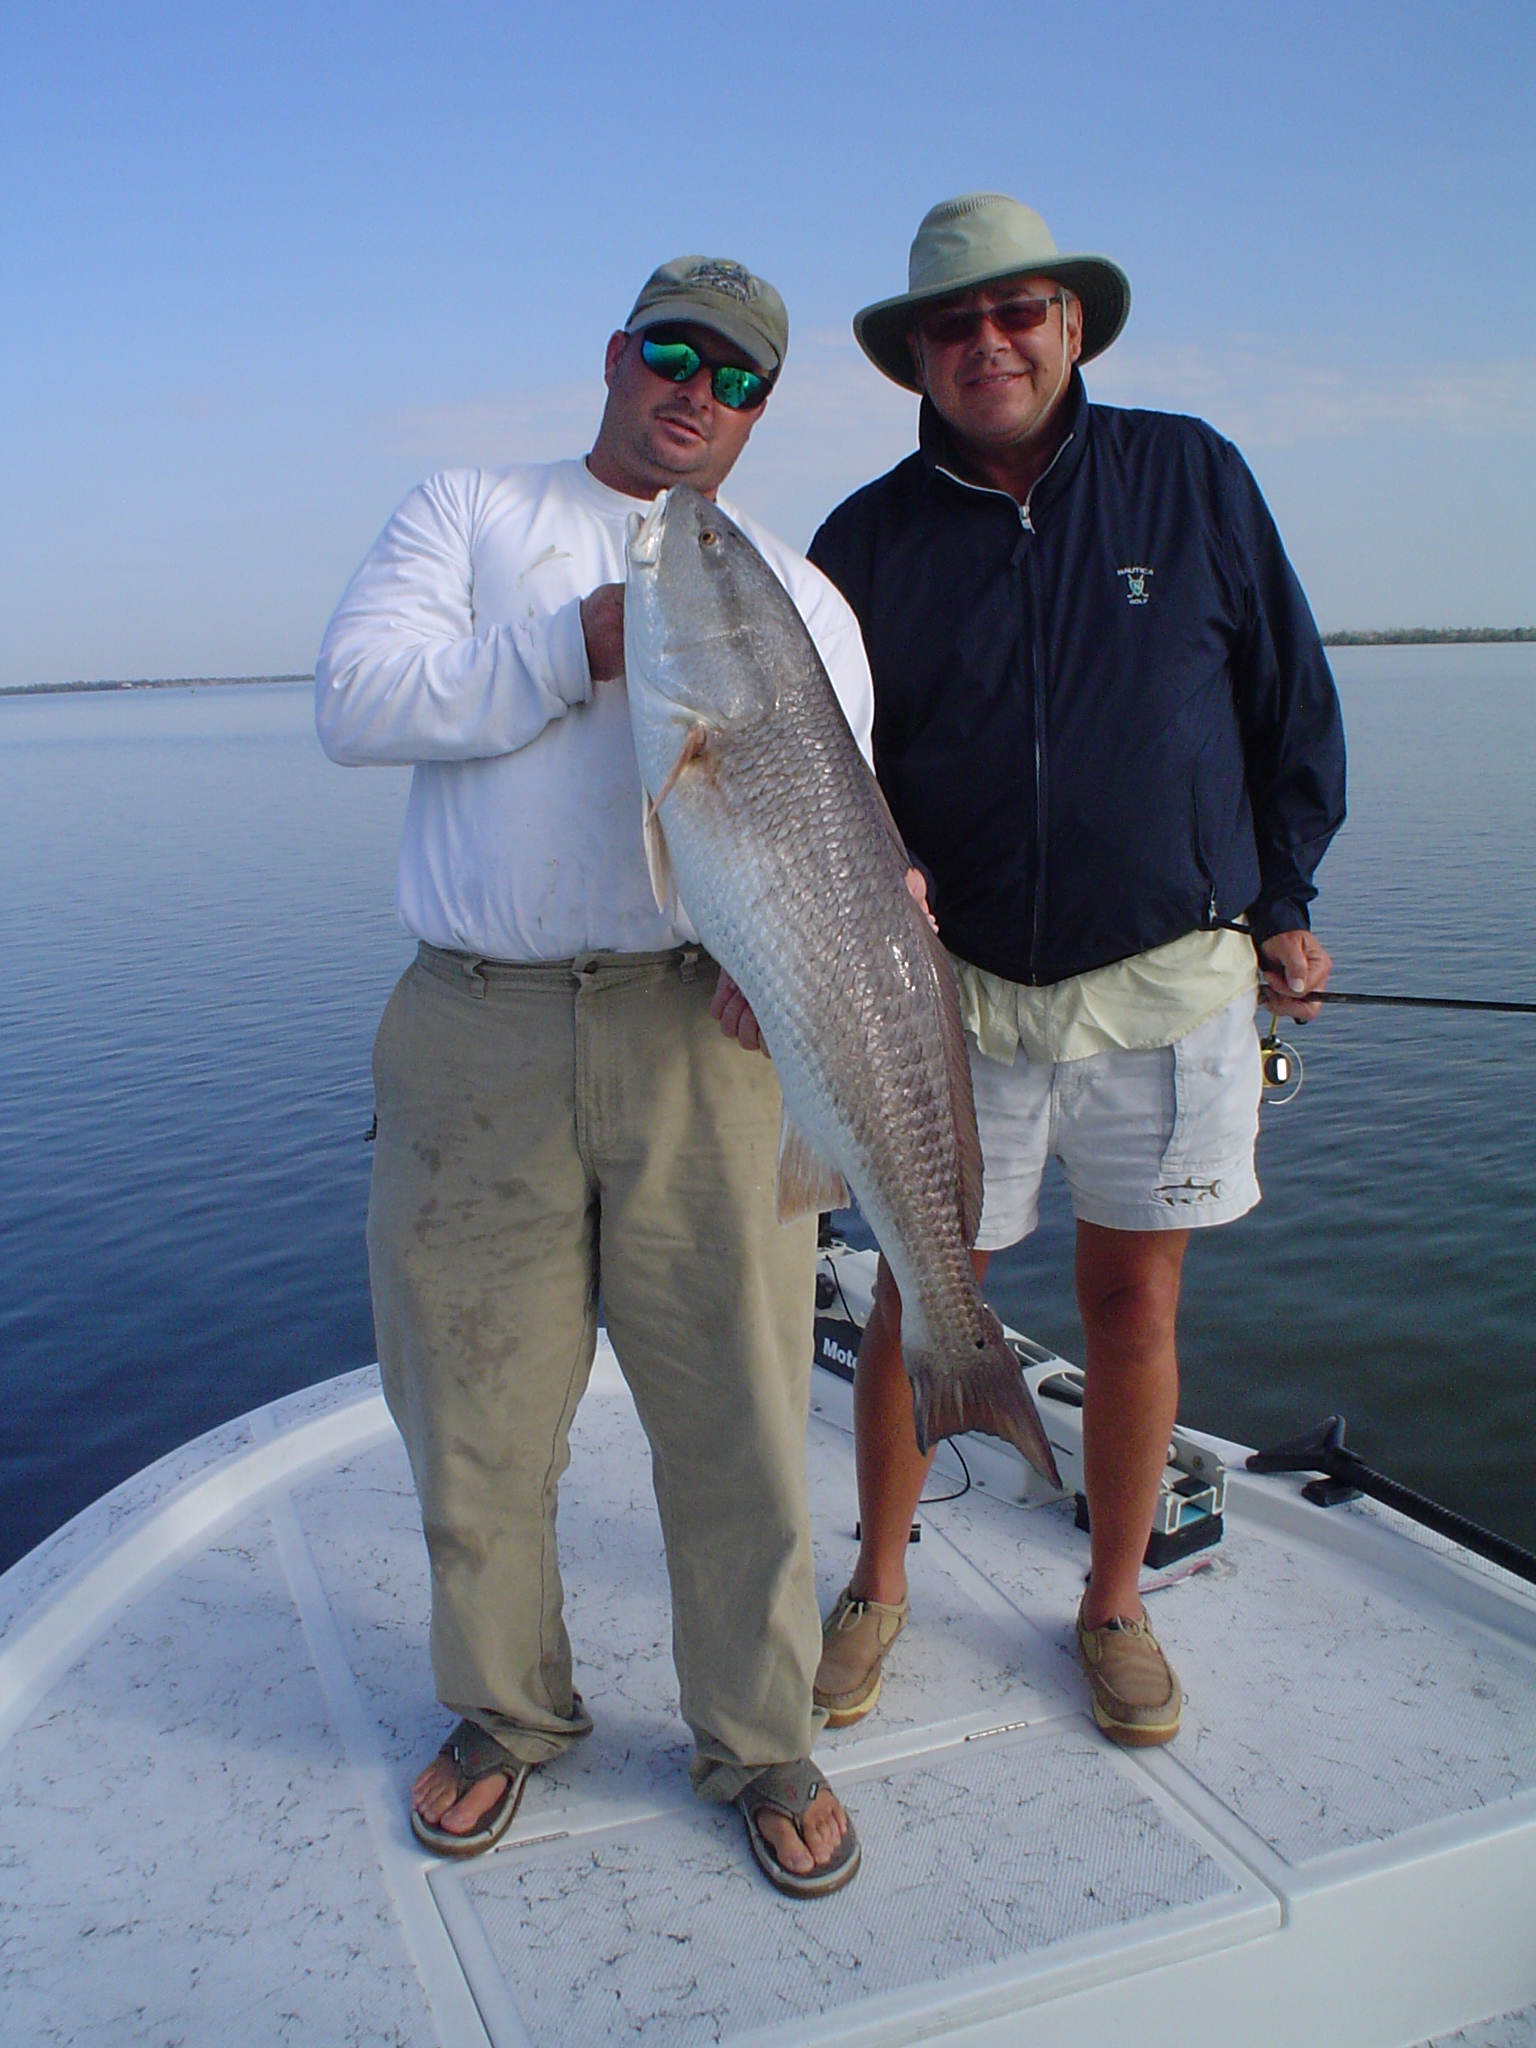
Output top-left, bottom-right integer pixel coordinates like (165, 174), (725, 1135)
(811, 193), (1343, 1745)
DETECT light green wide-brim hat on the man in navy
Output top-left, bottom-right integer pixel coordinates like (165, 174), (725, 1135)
(854, 193), (1130, 391)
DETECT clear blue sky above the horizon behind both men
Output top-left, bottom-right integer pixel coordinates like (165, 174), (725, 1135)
(0, 0), (1536, 682)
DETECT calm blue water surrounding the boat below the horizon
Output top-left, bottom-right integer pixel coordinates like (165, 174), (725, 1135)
(0, 647), (1536, 1565)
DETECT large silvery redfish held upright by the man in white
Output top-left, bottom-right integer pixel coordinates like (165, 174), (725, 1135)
(625, 485), (1061, 1485)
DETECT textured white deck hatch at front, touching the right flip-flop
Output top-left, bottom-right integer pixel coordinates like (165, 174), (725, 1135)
(434, 1726), (1257, 2048)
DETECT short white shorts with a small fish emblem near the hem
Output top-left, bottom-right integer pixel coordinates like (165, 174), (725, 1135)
(967, 995), (1262, 1251)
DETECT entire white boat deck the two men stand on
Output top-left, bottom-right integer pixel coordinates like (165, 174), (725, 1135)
(0, 1245), (1536, 2048)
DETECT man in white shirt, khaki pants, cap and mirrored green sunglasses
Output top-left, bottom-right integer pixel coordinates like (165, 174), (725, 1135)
(315, 256), (872, 1894)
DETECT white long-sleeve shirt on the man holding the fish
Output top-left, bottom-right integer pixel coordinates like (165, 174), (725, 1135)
(315, 461), (874, 961)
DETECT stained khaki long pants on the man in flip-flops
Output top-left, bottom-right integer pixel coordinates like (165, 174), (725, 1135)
(369, 946), (821, 1798)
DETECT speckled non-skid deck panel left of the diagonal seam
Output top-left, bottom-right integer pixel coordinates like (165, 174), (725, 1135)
(0, 1458), (432, 2048)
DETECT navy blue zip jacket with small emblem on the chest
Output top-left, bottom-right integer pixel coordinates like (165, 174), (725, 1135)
(811, 373), (1343, 983)
